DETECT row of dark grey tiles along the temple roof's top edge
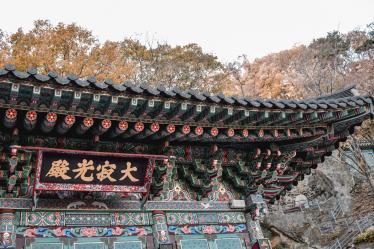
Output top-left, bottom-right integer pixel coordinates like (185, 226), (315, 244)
(0, 64), (373, 109)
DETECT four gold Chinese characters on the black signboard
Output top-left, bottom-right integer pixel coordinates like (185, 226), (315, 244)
(46, 159), (139, 182)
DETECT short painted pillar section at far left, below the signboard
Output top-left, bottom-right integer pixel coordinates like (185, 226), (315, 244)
(0, 210), (16, 248)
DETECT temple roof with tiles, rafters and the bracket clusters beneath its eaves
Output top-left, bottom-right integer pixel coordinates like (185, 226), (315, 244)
(0, 65), (374, 204)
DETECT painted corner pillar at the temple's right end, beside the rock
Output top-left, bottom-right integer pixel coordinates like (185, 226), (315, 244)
(245, 194), (271, 248)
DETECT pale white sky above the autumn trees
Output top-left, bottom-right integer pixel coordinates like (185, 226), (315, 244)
(0, 0), (374, 62)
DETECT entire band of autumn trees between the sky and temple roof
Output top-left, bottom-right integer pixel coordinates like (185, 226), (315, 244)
(0, 20), (374, 98)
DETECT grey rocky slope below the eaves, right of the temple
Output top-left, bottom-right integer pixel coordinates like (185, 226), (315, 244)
(262, 152), (374, 249)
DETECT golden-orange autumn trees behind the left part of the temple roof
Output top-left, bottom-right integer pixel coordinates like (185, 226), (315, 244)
(0, 20), (224, 92)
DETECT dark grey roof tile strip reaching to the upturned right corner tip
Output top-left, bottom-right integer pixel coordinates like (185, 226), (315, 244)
(0, 64), (373, 110)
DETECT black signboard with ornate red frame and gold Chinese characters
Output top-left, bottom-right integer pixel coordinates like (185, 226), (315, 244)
(24, 147), (167, 194)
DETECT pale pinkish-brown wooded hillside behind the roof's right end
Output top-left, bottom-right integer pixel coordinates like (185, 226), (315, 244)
(228, 23), (374, 98)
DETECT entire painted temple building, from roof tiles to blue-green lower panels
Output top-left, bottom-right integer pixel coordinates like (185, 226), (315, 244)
(0, 65), (373, 249)
